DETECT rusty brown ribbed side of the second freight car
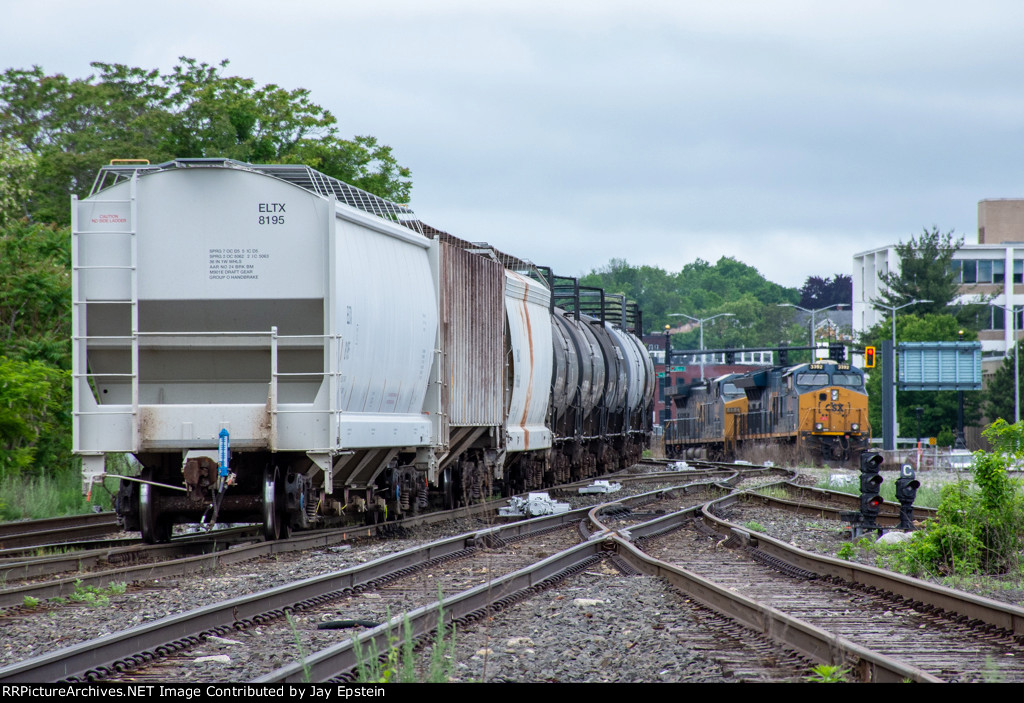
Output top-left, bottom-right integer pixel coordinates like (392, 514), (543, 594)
(440, 243), (505, 427)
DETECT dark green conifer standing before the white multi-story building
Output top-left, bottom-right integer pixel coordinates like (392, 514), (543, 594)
(874, 227), (964, 314)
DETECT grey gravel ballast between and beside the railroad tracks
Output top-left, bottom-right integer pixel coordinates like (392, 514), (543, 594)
(0, 470), (1007, 683)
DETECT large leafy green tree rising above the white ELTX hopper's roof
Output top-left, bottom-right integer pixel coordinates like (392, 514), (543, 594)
(0, 57), (412, 222)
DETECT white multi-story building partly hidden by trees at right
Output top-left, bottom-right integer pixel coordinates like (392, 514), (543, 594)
(853, 200), (1024, 374)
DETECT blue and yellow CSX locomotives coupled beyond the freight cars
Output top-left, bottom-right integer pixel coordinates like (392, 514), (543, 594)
(665, 359), (870, 463)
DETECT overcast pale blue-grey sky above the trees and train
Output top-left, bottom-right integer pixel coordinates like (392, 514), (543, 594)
(0, 0), (1024, 287)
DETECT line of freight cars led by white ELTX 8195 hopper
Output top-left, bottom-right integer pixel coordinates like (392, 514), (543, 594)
(72, 159), (655, 542)
